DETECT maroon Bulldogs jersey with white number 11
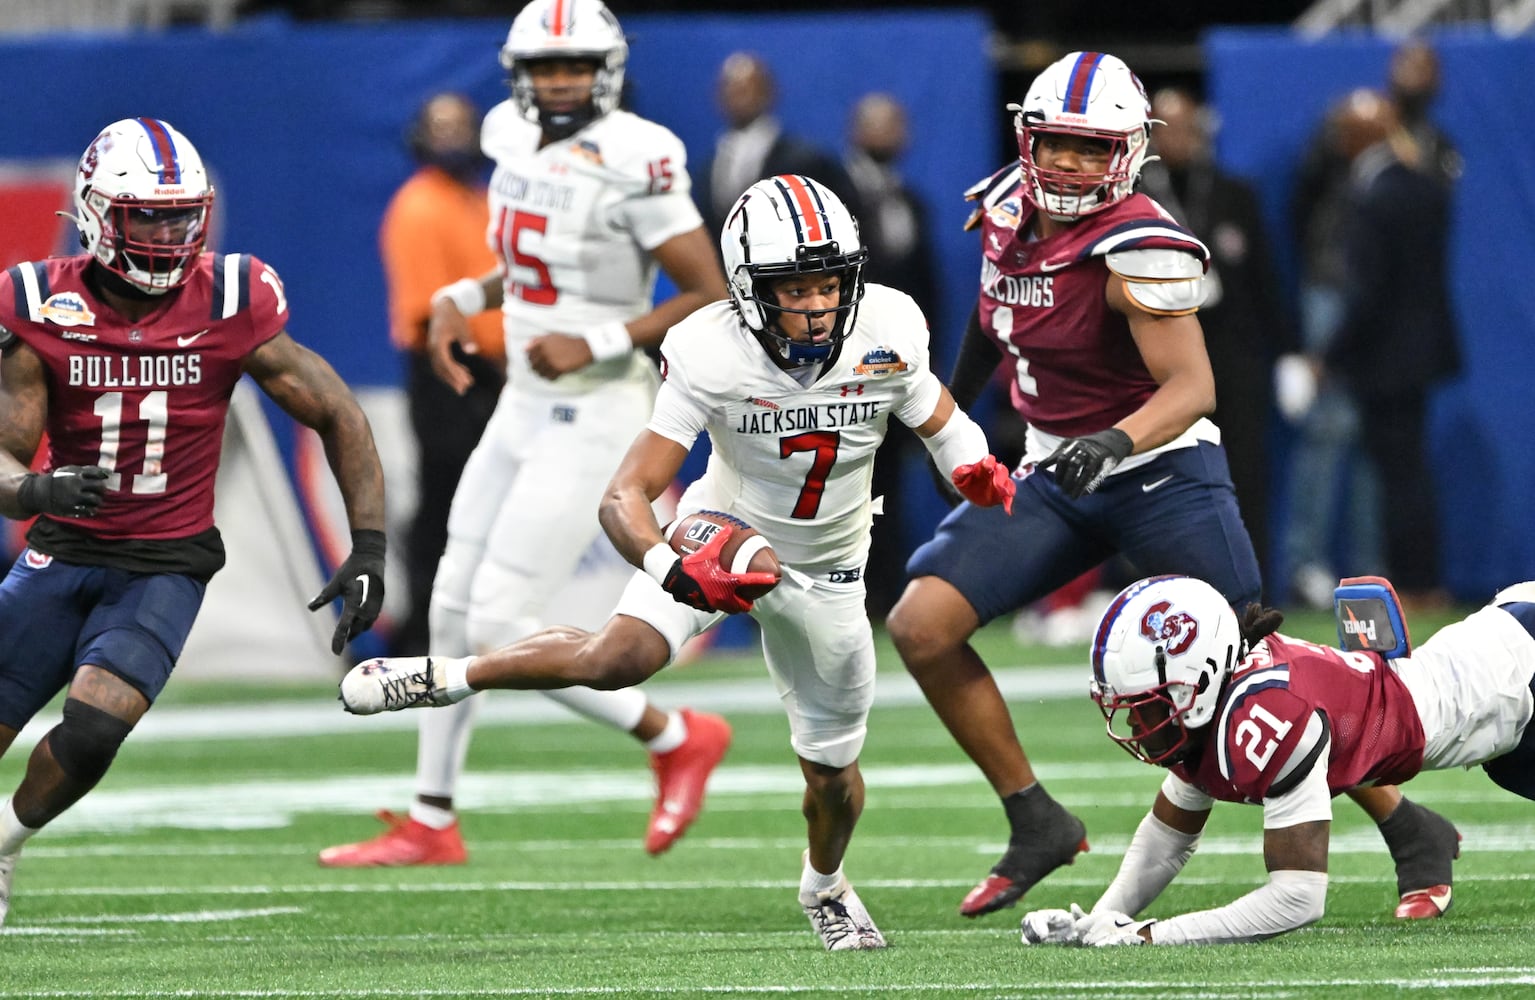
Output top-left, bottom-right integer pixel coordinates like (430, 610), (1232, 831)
(0, 253), (287, 539)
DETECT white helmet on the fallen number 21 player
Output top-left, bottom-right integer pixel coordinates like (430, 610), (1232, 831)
(1091, 576), (1245, 767)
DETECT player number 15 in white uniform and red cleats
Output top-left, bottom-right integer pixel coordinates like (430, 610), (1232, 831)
(319, 0), (731, 866)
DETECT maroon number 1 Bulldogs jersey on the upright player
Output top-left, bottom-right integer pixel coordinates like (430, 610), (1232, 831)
(972, 166), (1210, 438)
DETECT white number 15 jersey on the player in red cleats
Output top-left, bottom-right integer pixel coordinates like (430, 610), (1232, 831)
(480, 101), (703, 392)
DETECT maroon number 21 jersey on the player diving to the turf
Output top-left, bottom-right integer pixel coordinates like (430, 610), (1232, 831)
(1173, 634), (1423, 803)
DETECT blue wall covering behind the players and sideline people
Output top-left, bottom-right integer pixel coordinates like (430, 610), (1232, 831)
(0, 12), (1535, 599)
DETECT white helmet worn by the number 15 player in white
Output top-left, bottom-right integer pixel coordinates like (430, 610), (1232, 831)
(500, 0), (629, 138)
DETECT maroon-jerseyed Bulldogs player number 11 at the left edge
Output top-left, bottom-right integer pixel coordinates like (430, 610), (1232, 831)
(0, 118), (384, 922)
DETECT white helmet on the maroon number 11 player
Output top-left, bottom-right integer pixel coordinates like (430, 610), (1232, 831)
(72, 118), (213, 295)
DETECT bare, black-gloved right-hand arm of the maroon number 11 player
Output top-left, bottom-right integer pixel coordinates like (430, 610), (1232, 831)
(246, 332), (384, 654)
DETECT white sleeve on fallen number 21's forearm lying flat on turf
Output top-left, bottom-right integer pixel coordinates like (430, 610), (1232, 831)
(1151, 869), (1328, 945)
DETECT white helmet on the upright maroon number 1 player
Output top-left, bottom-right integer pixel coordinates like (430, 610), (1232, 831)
(1007, 52), (1151, 221)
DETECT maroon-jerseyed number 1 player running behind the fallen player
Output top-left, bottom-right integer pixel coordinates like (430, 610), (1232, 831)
(887, 52), (1457, 917)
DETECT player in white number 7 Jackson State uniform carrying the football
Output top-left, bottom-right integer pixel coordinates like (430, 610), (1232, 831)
(341, 175), (1013, 951)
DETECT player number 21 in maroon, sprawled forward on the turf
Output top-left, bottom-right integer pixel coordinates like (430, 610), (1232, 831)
(1024, 576), (1535, 946)
